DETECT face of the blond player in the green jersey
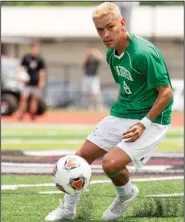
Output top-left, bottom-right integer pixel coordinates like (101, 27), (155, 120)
(94, 14), (125, 48)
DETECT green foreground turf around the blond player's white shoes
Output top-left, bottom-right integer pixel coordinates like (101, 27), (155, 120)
(1, 176), (184, 222)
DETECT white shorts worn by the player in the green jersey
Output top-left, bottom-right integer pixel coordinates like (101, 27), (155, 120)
(87, 116), (169, 171)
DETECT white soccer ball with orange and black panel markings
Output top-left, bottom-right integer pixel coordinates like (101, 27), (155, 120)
(53, 155), (92, 194)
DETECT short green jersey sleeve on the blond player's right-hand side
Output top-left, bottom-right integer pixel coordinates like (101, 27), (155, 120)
(135, 53), (170, 89)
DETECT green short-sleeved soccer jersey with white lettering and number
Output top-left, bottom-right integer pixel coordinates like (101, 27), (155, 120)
(106, 34), (173, 125)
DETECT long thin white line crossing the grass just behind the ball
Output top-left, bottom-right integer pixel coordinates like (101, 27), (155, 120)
(1, 176), (184, 190)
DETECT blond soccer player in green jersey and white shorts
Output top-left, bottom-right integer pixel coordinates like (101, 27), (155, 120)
(46, 2), (173, 221)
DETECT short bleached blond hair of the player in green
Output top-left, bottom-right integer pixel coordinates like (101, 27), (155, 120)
(92, 2), (122, 20)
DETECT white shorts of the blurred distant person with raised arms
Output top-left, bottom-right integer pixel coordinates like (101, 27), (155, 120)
(82, 76), (100, 94)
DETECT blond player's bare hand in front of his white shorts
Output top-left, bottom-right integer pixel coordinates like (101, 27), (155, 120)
(122, 122), (145, 142)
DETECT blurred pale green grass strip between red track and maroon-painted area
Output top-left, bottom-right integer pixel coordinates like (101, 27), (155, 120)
(1, 124), (184, 152)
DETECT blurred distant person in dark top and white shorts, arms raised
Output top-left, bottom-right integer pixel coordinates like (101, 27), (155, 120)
(81, 48), (104, 110)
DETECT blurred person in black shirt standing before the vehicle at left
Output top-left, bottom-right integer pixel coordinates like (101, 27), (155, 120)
(16, 41), (46, 120)
